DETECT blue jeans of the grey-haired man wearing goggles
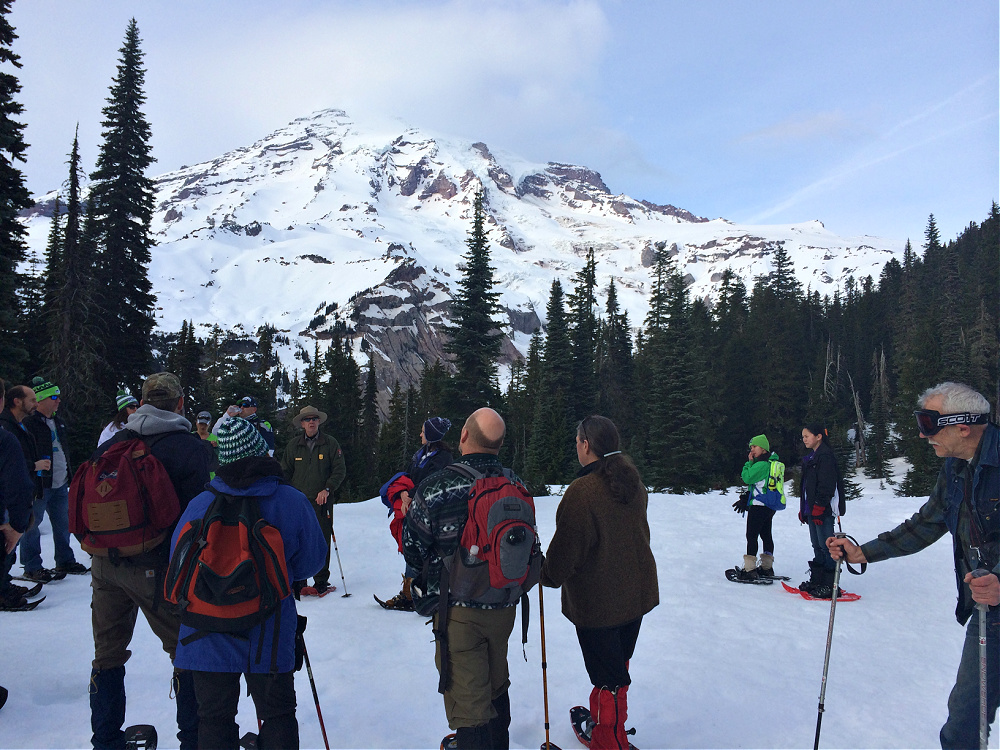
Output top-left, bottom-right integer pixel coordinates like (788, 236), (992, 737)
(940, 607), (1000, 750)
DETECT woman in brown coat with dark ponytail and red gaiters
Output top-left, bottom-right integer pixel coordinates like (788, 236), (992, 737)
(542, 416), (660, 750)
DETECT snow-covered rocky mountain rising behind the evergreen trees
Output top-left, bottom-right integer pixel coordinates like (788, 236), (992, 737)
(28, 109), (902, 394)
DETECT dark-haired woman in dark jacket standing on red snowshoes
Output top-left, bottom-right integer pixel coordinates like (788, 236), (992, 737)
(799, 424), (837, 599)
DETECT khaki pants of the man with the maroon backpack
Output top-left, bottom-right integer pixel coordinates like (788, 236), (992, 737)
(90, 549), (181, 670)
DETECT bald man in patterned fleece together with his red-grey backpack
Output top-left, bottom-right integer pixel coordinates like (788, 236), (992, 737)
(403, 408), (540, 750)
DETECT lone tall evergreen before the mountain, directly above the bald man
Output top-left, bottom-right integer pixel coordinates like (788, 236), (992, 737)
(445, 190), (502, 418)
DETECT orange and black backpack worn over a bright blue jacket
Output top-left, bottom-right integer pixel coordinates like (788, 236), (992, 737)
(163, 488), (292, 670)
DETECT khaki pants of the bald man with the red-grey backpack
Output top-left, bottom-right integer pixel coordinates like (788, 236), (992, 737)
(434, 607), (517, 730)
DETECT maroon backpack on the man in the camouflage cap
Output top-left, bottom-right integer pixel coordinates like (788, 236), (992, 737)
(69, 436), (181, 558)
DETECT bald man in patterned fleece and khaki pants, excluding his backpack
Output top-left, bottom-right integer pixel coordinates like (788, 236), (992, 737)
(403, 408), (520, 750)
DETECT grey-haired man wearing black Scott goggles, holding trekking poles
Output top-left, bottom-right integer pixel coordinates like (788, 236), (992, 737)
(827, 383), (1000, 748)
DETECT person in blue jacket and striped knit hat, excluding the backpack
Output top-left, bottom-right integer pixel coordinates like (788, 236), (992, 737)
(171, 417), (326, 748)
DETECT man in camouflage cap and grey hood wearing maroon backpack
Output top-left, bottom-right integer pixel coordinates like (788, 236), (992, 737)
(81, 372), (211, 750)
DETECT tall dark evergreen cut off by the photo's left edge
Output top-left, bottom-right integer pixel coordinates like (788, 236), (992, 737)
(0, 0), (31, 381)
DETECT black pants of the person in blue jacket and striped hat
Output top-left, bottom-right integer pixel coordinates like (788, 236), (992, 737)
(193, 671), (299, 750)
